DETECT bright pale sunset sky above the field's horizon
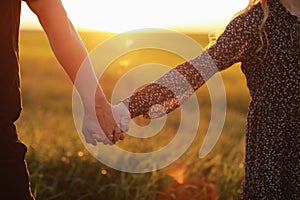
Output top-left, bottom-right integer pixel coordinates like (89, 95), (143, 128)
(21, 0), (248, 32)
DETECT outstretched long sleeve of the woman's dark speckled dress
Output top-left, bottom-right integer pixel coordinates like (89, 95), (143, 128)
(123, 9), (253, 118)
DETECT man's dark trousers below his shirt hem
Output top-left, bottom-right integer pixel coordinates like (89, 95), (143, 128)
(0, 123), (34, 200)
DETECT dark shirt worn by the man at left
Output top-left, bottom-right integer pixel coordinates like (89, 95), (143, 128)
(0, 0), (21, 125)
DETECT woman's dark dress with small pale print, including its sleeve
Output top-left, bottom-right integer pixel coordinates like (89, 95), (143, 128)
(123, 0), (300, 200)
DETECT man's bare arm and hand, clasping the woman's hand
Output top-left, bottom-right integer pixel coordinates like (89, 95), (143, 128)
(27, 0), (124, 145)
